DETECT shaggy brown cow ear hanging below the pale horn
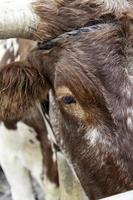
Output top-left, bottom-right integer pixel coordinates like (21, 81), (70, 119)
(0, 62), (49, 120)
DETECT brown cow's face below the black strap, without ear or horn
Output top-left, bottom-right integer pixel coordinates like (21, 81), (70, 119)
(29, 21), (133, 199)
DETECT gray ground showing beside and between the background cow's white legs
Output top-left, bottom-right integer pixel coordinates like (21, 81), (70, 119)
(0, 169), (44, 200)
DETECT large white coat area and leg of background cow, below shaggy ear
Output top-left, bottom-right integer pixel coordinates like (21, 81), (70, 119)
(0, 122), (44, 200)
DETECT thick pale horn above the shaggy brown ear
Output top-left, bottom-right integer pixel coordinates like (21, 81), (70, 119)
(0, 0), (39, 40)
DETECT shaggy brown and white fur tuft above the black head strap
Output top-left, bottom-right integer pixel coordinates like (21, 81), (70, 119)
(33, 0), (133, 41)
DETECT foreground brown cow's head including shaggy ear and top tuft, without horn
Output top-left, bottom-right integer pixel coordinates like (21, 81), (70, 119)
(0, 0), (133, 200)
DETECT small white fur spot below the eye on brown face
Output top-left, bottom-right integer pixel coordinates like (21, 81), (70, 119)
(85, 128), (101, 146)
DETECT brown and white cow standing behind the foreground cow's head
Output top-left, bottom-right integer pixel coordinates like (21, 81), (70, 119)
(0, 39), (59, 200)
